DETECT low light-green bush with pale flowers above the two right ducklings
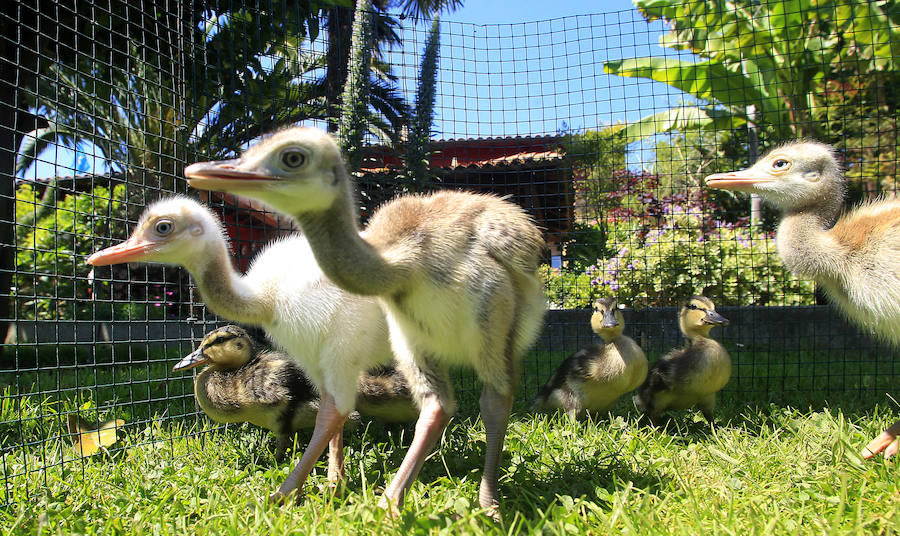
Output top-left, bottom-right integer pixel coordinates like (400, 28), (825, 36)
(586, 211), (815, 306)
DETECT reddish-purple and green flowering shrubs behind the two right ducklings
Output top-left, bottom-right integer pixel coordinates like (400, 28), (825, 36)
(541, 170), (815, 308)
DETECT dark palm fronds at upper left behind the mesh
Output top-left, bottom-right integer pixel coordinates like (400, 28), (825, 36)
(17, 0), (398, 178)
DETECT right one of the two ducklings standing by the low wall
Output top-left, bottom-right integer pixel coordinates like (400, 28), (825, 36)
(634, 296), (731, 424)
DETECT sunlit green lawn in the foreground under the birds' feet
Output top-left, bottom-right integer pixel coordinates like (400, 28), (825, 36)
(0, 386), (900, 535)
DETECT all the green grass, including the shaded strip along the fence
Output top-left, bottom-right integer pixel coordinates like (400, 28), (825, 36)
(0, 347), (900, 535)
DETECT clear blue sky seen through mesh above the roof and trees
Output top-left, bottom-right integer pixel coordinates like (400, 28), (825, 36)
(26, 0), (680, 178)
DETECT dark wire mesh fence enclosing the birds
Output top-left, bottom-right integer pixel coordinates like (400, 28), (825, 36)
(0, 0), (900, 503)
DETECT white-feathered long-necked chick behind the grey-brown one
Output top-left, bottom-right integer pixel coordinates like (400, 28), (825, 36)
(87, 197), (391, 490)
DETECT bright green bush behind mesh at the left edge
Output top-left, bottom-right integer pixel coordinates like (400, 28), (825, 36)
(14, 183), (125, 320)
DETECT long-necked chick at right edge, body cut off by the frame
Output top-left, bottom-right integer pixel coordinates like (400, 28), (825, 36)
(706, 141), (900, 458)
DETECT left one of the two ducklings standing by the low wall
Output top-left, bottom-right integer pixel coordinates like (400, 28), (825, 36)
(532, 298), (647, 418)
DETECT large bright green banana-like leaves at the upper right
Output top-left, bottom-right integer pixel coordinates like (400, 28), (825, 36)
(604, 0), (900, 139)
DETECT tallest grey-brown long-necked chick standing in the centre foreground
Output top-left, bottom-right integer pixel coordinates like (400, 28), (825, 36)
(185, 127), (546, 516)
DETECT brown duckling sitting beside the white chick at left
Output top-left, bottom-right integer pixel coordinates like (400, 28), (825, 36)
(172, 325), (319, 462)
